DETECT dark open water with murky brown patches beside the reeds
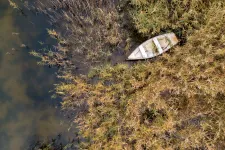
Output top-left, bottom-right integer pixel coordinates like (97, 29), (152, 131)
(0, 0), (72, 150)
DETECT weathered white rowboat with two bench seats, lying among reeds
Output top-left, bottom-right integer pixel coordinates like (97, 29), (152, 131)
(128, 33), (178, 60)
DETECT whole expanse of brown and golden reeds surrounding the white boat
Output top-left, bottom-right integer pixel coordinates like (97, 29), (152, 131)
(23, 0), (225, 150)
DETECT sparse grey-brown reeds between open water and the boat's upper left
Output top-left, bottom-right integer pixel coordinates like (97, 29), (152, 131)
(29, 0), (123, 63)
